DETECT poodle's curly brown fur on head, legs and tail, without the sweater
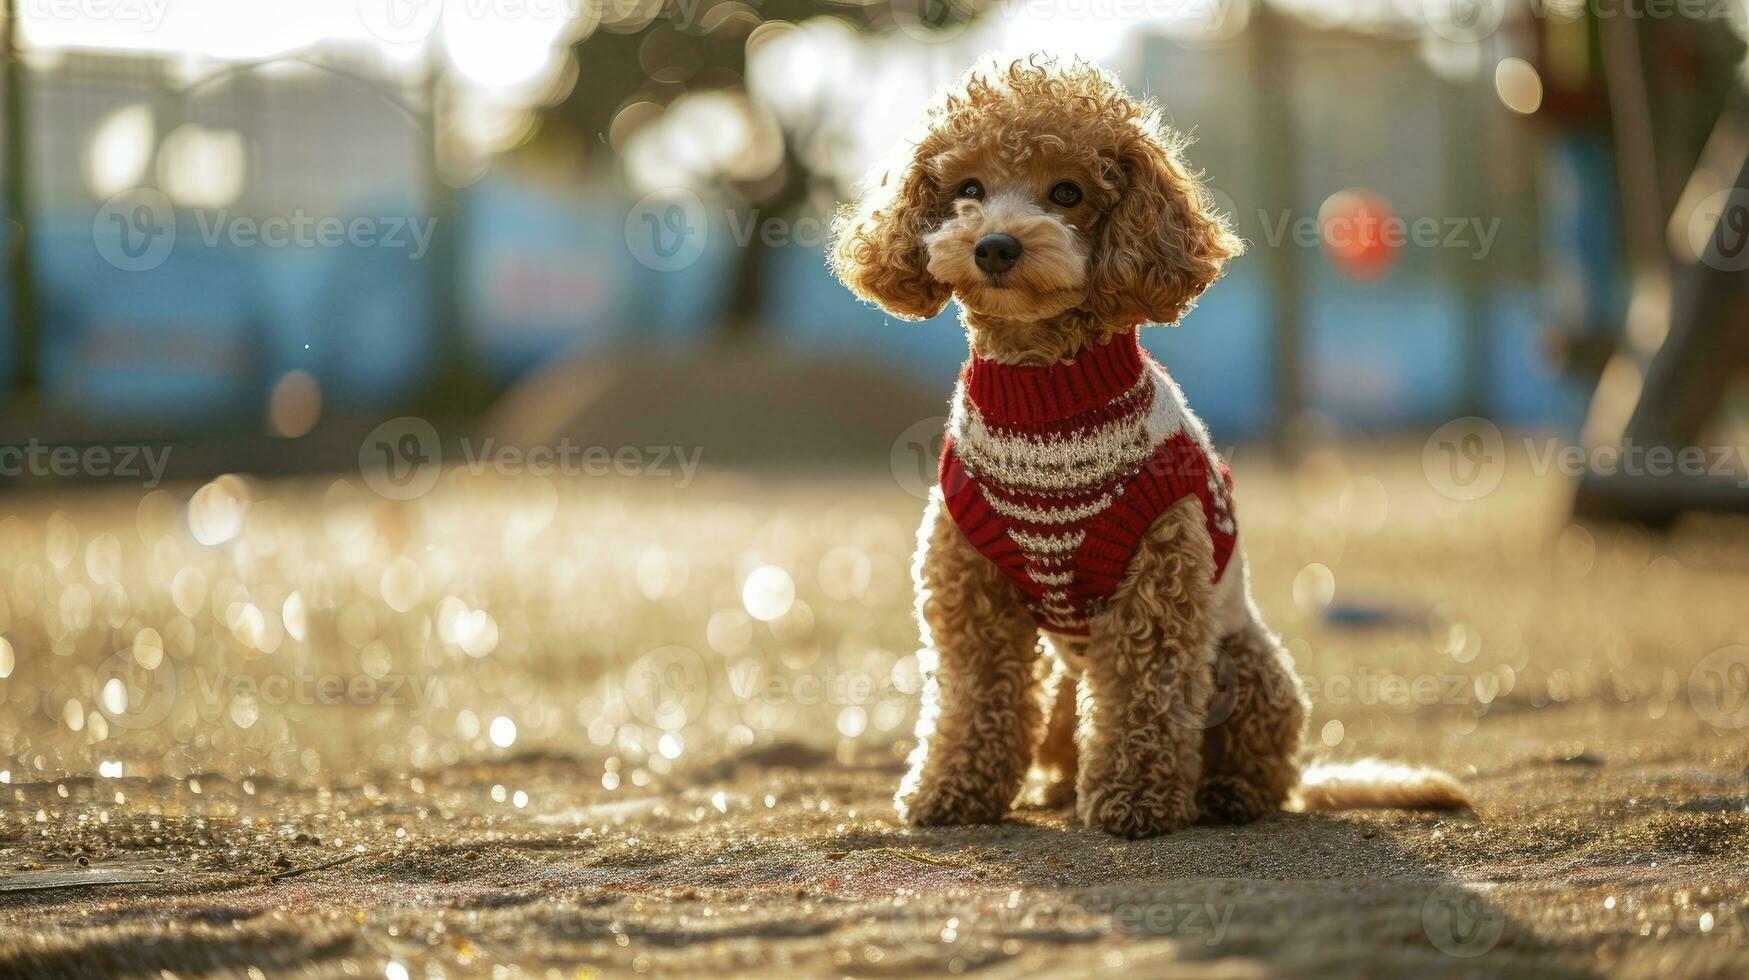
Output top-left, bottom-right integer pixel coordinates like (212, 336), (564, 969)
(853, 56), (1462, 837)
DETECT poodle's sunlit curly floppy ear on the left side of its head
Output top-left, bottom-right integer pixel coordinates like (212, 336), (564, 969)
(827, 141), (953, 320)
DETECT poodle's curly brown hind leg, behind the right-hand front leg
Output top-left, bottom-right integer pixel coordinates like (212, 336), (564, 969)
(1196, 588), (1310, 823)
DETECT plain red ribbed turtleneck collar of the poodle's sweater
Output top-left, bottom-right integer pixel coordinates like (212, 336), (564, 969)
(962, 329), (1144, 422)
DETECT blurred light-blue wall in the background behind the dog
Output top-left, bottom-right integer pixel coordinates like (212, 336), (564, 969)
(0, 177), (1578, 439)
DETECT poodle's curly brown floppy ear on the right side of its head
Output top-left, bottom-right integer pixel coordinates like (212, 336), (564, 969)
(1088, 119), (1245, 324)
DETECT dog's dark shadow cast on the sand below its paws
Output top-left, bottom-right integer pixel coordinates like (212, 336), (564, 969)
(840, 807), (1550, 975)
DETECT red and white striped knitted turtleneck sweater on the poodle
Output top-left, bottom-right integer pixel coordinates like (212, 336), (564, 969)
(941, 331), (1237, 635)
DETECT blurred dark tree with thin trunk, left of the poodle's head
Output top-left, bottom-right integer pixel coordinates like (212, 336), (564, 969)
(537, 0), (988, 341)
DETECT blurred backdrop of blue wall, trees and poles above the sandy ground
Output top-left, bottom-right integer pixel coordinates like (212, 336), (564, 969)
(0, 0), (1744, 455)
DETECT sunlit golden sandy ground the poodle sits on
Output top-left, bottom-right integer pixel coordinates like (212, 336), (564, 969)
(0, 446), (1749, 980)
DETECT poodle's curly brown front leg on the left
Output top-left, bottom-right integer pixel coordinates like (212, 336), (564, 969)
(894, 492), (1044, 824)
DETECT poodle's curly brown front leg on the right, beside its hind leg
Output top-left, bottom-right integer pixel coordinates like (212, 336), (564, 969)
(1076, 499), (1214, 838)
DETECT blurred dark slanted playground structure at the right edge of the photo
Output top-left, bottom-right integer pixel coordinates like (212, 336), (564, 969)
(1574, 23), (1749, 527)
